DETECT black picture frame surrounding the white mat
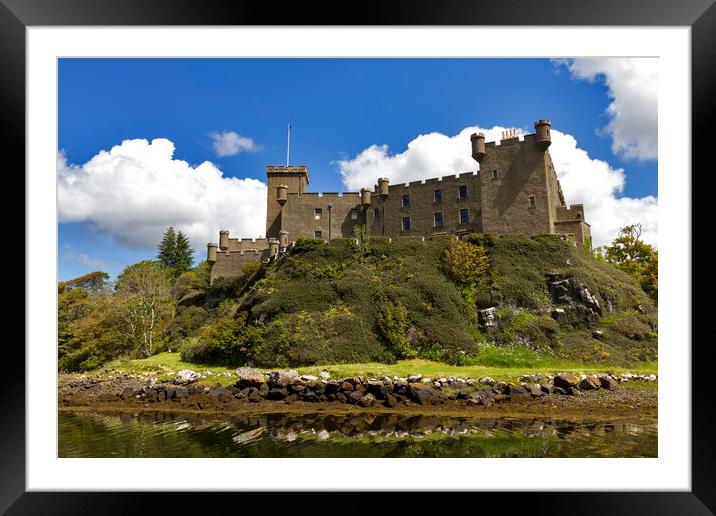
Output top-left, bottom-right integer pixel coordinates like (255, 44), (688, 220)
(0, 0), (716, 515)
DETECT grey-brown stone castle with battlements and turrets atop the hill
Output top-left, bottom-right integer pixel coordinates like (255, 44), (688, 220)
(207, 120), (591, 282)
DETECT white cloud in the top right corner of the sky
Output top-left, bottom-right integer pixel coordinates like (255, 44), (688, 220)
(556, 57), (659, 160)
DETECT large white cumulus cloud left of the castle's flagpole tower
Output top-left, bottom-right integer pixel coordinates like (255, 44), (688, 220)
(57, 138), (267, 250)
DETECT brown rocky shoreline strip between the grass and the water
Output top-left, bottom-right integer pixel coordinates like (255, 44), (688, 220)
(58, 372), (658, 421)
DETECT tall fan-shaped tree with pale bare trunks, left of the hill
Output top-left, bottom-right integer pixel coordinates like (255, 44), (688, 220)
(115, 260), (173, 357)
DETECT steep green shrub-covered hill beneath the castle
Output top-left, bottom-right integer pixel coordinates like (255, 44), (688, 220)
(168, 235), (657, 367)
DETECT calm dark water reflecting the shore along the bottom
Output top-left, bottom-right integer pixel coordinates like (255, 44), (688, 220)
(59, 411), (657, 457)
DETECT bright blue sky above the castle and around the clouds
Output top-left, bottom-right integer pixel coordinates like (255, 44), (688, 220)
(58, 59), (657, 280)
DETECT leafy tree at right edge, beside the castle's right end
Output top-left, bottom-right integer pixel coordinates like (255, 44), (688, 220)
(599, 224), (659, 301)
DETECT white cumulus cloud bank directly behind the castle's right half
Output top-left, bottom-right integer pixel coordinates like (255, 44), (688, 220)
(337, 126), (658, 246)
